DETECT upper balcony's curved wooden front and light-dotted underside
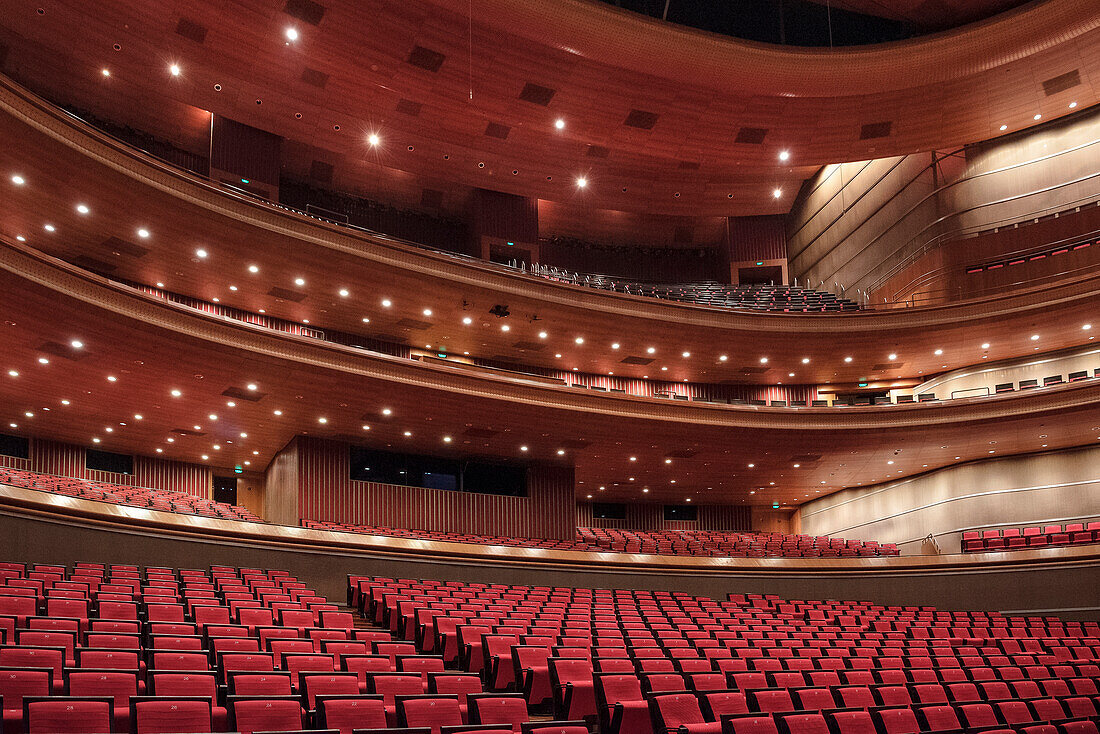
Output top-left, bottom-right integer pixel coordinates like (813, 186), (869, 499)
(0, 79), (1100, 396)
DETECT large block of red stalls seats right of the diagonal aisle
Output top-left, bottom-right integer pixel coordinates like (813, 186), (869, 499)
(349, 577), (1100, 734)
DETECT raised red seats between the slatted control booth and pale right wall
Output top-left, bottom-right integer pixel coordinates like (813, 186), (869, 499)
(576, 527), (900, 558)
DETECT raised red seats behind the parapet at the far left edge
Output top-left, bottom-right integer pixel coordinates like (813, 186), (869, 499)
(0, 467), (263, 523)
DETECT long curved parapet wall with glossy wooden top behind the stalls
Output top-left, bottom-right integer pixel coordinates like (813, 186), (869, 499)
(0, 485), (1100, 620)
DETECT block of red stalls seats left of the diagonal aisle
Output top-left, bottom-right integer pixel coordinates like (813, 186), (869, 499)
(0, 563), (598, 734)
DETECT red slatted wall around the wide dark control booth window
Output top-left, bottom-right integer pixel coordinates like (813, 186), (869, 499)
(298, 437), (575, 539)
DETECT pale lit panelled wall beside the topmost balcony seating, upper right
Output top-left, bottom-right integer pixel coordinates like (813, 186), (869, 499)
(788, 103), (1100, 300)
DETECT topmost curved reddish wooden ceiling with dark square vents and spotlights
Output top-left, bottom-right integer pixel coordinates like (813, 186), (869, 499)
(0, 0), (1100, 216)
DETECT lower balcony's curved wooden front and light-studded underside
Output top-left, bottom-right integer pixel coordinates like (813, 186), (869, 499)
(0, 236), (1100, 506)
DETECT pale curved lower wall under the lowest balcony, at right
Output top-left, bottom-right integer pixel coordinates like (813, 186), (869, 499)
(796, 444), (1100, 554)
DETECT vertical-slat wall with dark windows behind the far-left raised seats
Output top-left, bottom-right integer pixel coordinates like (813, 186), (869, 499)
(0, 438), (213, 497)
